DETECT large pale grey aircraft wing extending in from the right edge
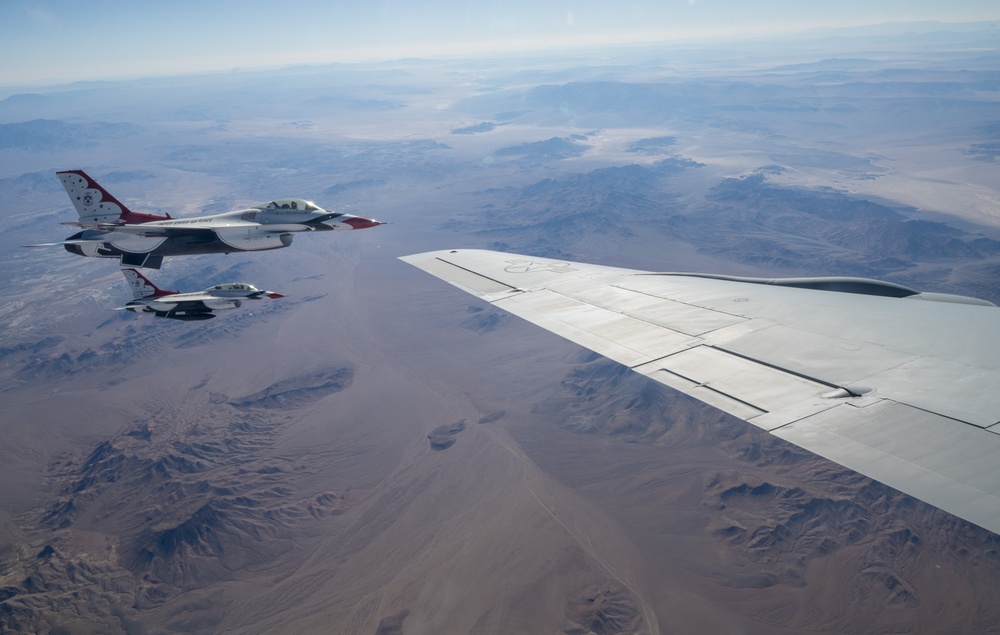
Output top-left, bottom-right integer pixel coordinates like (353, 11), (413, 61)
(402, 250), (1000, 533)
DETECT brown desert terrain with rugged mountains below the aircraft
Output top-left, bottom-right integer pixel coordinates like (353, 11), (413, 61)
(0, 22), (1000, 635)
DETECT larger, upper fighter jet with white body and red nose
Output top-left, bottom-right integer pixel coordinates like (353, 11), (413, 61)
(28, 170), (385, 269)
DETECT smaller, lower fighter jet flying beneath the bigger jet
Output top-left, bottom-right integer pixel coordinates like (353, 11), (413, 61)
(117, 269), (285, 320)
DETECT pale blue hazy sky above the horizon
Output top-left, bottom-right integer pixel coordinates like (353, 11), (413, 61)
(0, 0), (1000, 86)
